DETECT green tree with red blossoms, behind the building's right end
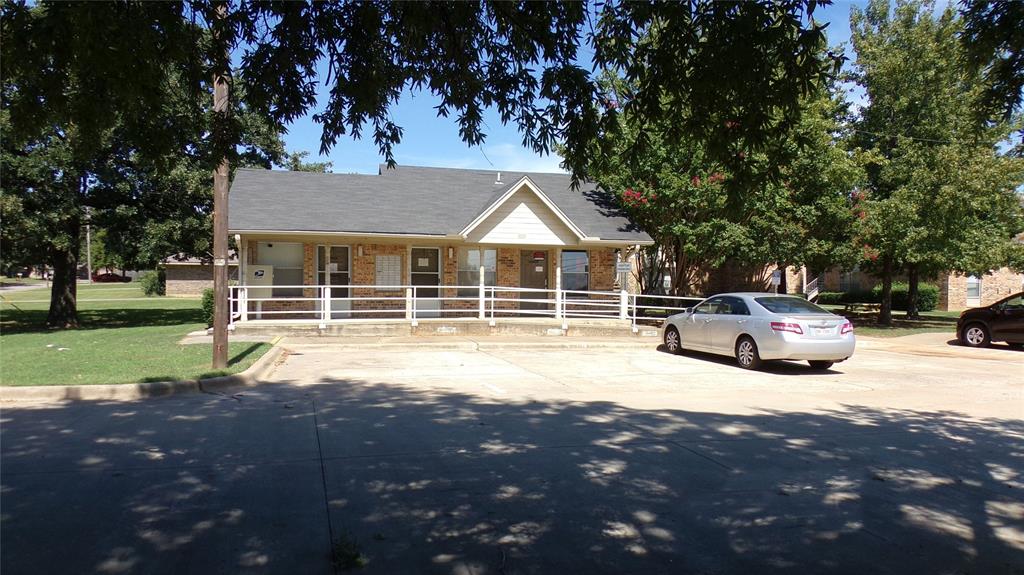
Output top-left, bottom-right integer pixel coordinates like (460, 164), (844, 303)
(590, 71), (860, 295)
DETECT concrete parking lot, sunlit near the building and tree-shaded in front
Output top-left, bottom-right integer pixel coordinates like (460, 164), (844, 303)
(0, 337), (1024, 574)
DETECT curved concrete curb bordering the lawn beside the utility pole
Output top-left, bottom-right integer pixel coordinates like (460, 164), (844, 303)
(0, 343), (286, 402)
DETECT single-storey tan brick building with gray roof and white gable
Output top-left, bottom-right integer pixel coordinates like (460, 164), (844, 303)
(228, 166), (652, 318)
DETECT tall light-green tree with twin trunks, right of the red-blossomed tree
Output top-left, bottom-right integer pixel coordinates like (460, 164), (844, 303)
(852, 0), (1021, 324)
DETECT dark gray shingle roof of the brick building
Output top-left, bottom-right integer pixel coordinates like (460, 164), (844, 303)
(228, 166), (650, 241)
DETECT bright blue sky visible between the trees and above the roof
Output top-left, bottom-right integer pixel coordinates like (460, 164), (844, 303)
(285, 0), (865, 174)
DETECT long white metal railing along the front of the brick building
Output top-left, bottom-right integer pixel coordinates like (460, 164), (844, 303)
(229, 285), (701, 329)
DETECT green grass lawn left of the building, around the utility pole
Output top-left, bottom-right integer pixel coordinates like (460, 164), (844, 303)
(0, 283), (270, 386)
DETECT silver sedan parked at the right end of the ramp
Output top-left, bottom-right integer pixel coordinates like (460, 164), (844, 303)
(663, 293), (855, 369)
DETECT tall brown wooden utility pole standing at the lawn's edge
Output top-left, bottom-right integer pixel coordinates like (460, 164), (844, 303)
(213, 3), (230, 369)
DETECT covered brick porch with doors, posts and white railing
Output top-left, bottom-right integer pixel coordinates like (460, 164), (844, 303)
(230, 237), (632, 324)
